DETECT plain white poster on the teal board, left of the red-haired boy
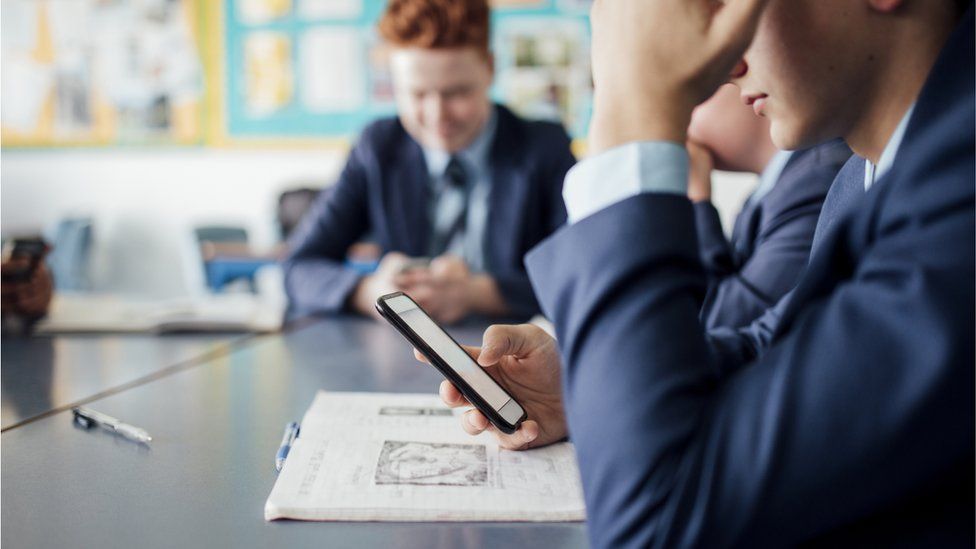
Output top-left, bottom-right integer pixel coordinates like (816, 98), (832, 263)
(301, 26), (366, 113)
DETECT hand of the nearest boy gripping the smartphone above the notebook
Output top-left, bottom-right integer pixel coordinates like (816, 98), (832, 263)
(414, 324), (568, 450)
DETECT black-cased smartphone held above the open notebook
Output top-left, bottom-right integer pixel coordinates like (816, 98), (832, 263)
(376, 292), (526, 434)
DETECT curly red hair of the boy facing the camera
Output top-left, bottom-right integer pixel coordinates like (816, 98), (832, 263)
(379, 0), (489, 54)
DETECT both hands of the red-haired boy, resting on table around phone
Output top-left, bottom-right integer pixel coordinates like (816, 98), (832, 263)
(352, 252), (507, 324)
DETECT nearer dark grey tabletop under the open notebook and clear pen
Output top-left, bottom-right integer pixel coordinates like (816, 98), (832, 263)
(0, 319), (586, 549)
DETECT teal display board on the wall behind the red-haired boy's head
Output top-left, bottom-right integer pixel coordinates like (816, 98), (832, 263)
(222, 0), (592, 139)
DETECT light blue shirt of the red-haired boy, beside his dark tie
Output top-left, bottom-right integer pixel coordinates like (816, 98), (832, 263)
(424, 107), (498, 272)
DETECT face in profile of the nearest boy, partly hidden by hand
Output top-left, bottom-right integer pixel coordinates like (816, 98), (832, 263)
(734, 0), (878, 149)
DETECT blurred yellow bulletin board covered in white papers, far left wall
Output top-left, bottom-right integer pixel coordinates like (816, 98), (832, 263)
(0, 0), (206, 147)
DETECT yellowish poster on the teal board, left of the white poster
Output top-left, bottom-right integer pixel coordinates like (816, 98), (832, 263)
(244, 32), (294, 117)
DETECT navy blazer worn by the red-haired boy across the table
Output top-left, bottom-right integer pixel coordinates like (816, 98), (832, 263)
(284, 105), (575, 317)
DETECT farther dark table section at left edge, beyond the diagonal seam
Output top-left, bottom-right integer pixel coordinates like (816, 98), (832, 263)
(0, 334), (247, 430)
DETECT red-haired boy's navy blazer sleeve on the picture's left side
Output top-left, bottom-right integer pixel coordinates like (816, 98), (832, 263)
(284, 139), (371, 314)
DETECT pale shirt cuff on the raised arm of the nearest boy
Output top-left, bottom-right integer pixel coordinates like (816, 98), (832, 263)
(563, 141), (688, 224)
